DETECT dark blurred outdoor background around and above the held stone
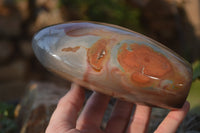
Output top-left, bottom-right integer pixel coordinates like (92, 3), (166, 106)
(0, 0), (200, 133)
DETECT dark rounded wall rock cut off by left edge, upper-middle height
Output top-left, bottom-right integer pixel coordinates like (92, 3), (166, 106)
(0, 40), (15, 64)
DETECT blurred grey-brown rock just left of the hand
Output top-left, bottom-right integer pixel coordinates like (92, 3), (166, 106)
(16, 82), (67, 133)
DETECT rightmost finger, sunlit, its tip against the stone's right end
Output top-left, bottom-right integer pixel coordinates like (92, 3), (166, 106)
(155, 102), (190, 133)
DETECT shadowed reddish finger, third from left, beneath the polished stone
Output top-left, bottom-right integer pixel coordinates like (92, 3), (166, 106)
(105, 100), (133, 133)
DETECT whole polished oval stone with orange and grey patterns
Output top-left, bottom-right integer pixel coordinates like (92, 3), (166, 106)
(33, 22), (192, 109)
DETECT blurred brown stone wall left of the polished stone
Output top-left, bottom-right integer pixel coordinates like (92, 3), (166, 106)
(0, 0), (68, 101)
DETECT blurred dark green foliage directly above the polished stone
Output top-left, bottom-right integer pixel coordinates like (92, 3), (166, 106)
(60, 0), (142, 31)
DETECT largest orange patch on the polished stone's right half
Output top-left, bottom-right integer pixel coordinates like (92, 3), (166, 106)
(118, 43), (172, 83)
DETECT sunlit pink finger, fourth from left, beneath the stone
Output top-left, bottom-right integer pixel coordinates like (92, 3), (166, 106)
(128, 105), (151, 133)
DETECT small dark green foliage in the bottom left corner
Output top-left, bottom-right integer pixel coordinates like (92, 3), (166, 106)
(0, 103), (17, 133)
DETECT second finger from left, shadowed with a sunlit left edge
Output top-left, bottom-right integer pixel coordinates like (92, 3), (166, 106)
(76, 92), (110, 130)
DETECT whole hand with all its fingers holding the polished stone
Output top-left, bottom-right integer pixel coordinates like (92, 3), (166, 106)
(46, 84), (190, 133)
